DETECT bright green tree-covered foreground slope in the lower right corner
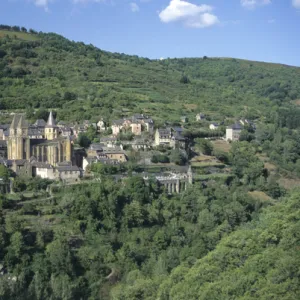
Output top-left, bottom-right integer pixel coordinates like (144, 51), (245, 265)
(112, 190), (300, 300)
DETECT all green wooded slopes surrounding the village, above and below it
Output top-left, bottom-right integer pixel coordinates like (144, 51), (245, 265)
(0, 25), (300, 300)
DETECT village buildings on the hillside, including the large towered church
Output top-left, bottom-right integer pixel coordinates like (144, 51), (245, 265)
(0, 109), (253, 190)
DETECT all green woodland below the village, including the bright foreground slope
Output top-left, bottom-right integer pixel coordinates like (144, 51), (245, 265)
(0, 142), (300, 300)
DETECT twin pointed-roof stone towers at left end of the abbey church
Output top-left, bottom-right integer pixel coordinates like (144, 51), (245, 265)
(8, 115), (30, 160)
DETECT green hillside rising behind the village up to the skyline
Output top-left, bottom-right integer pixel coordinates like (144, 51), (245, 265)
(0, 30), (300, 120)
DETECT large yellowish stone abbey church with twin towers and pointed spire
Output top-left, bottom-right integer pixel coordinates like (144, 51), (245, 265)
(7, 112), (72, 166)
